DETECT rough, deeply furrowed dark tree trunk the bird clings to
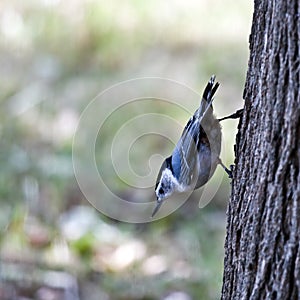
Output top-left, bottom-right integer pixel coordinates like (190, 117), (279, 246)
(222, 0), (300, 300)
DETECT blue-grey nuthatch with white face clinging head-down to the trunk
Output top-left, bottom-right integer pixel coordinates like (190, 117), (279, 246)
(152, 75), (243, 218)
